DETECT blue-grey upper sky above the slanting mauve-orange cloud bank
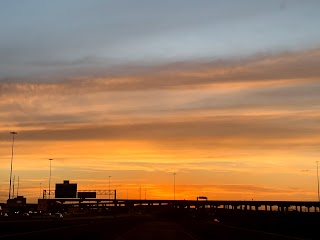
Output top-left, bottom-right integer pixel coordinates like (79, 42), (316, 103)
(0, 0), (320, 78)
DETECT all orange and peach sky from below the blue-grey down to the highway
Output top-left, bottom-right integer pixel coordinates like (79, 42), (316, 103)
(0, 49), (320, 202)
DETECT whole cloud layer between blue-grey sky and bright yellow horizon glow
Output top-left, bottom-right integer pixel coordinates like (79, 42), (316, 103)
(0, 49), (320, 148)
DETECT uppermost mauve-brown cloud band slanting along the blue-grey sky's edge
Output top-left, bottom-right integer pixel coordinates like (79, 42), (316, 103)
(0, 49), (320, 91)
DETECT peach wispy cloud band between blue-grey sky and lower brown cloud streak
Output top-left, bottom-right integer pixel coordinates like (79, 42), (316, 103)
(0, 49), (320, 129)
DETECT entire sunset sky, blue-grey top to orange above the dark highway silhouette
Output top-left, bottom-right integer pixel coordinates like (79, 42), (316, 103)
(0, 0), (320, 202)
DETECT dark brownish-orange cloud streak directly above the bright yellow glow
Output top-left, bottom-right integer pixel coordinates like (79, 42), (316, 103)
(2, 116), (318, 146)
